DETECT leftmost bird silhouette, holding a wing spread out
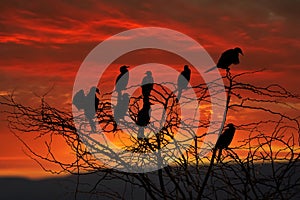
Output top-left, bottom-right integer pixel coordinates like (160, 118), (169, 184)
(73, 87), (100, 132)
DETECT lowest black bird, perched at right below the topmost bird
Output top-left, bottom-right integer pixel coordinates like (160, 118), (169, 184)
(215, 123), (235, 162)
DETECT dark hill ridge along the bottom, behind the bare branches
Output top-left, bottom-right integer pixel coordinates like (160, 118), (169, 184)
(0, 163), (300, 200)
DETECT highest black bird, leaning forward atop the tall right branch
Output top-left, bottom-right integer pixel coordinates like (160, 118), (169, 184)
(205, 47), (244, 73)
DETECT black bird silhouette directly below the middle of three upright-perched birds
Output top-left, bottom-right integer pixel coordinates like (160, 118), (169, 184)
(136, 102), (152, 139)
